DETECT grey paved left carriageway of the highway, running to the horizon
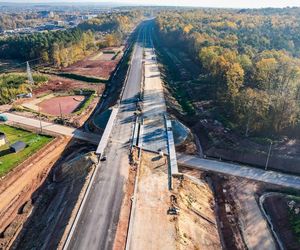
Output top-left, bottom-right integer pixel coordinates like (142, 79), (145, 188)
(68, 22), (148, 250)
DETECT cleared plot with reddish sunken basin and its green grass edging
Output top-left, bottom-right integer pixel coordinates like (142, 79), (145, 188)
(12, 76), (101, 127)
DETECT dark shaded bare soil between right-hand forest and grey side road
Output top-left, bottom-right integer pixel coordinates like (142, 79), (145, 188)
(193, 119), (300, 174)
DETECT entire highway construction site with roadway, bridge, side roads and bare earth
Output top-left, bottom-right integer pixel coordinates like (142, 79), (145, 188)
(0, 15), (300, 250)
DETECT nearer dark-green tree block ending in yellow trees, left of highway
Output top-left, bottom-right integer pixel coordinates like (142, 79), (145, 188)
(0, 29), (94, 67)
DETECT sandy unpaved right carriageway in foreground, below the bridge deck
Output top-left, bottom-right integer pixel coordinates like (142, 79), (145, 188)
(129, 152), (177, 250)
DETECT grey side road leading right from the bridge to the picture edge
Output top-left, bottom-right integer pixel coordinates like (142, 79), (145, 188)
(177, 154), (300, 189)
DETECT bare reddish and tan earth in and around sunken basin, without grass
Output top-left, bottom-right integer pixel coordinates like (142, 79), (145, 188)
(13, 75), (101, 127)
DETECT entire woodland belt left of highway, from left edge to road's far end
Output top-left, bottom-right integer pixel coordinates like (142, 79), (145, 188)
(0, 11), (141, 67)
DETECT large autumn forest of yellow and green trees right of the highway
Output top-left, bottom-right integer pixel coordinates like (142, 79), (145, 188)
(156, 8), (300, 135)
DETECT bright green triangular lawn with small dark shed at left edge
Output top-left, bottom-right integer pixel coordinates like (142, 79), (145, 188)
(0, 124), (52, 177)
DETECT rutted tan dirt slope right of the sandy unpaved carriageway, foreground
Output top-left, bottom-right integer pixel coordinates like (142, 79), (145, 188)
(174, 175), (221, 250)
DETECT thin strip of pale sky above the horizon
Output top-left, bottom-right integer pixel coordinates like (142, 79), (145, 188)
(0, 0), (300, 8)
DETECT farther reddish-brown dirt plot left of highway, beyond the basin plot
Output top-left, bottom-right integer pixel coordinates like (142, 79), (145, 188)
(62, 48), (123, 80)
